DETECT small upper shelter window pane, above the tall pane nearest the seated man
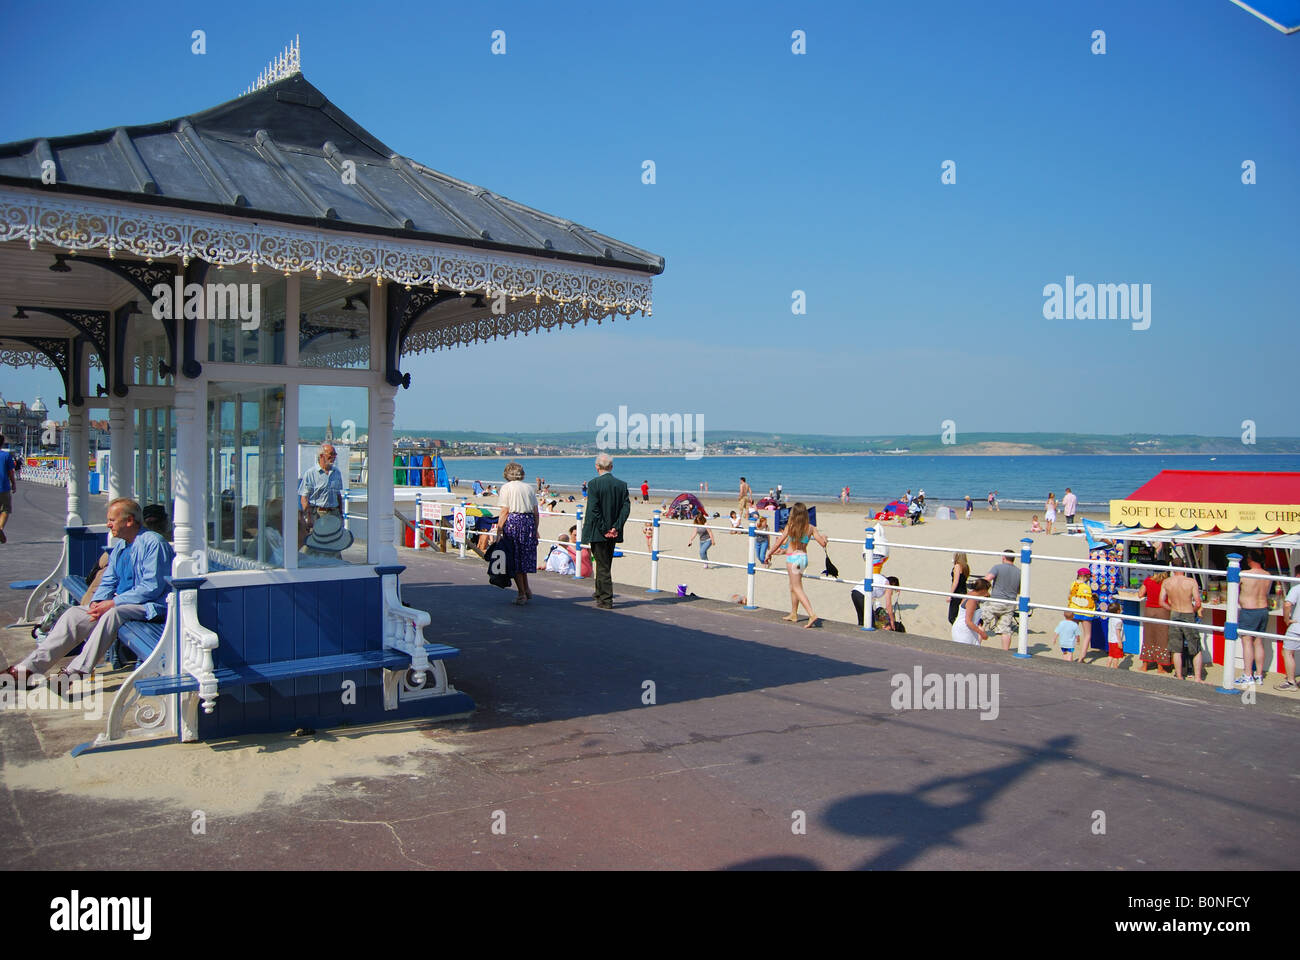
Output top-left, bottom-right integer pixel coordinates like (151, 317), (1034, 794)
(204, 267), (286, 363)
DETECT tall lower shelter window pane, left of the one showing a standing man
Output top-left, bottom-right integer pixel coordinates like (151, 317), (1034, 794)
(207, 382), (285, 570)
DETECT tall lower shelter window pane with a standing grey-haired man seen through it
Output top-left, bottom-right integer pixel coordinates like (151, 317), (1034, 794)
(296, 386), (369, 567)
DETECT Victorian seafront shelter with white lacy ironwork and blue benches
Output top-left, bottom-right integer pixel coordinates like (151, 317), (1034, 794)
(0, 47), (663, 744)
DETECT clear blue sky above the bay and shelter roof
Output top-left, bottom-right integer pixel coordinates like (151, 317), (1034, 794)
(0, 0), (1300, 436)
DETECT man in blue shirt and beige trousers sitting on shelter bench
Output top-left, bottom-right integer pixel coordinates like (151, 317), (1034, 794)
(5, 497), (172, 688)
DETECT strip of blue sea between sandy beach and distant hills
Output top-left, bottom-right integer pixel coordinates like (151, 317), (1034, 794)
(434, 451), (1300, 510)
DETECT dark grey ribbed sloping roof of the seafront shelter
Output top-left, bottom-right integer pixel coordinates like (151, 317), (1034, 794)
(0, 73), (664, 274)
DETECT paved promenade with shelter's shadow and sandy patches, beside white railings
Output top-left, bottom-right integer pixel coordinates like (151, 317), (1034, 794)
(0, 484), (1300, 870)
